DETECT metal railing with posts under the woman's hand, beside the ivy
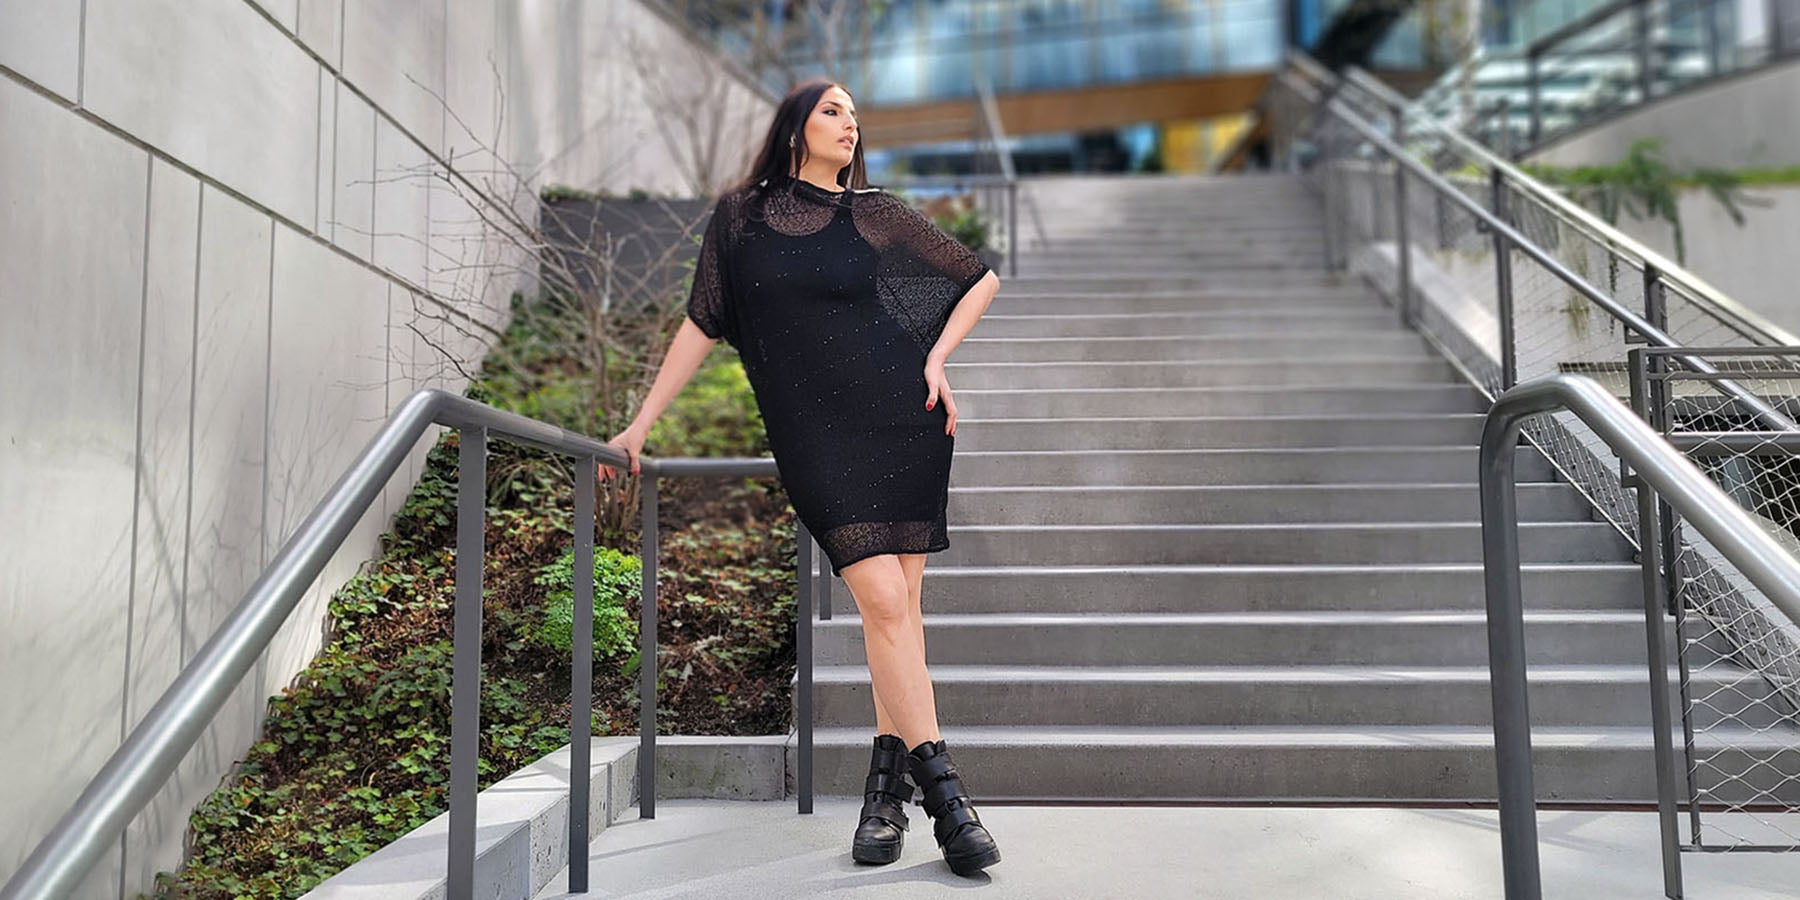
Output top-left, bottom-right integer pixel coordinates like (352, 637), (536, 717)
(0, 389), (830, 900)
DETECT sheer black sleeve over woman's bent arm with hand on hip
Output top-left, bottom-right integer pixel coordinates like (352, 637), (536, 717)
(857, 191), (990, 353)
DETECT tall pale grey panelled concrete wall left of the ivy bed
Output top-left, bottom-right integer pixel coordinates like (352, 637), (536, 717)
(0, 0), (770, 898)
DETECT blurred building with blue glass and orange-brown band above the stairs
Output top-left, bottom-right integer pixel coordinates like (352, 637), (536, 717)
(657, 0), (1472, 182)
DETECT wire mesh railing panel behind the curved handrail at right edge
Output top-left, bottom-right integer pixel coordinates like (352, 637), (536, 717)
(1640, 347), (1800, 851)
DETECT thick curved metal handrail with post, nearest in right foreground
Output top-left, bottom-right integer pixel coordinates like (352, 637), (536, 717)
(1480, 374), (1800, 900)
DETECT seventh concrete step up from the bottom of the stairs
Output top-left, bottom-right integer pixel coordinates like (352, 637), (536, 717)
(950, 445), (1555, 488)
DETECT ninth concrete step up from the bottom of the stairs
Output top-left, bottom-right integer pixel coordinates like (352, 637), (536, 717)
(952, 383), (1489, 421)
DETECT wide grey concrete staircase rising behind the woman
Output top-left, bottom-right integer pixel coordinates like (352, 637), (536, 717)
(795, 176), (1764, 801)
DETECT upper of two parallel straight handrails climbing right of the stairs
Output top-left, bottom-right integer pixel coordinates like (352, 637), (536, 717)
(1289, 50), (1800, 346)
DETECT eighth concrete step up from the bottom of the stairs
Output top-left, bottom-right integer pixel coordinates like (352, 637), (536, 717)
(956, 412), (1485, 448)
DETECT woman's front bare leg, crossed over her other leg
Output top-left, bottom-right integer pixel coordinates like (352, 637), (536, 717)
(842, 553), (940, 749)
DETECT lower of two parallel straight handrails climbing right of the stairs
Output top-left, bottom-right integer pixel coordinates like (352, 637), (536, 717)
(1280, 72), (1800, 430)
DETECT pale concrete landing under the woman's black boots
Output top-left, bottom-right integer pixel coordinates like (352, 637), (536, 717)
(538, 797), (1800, 900)
